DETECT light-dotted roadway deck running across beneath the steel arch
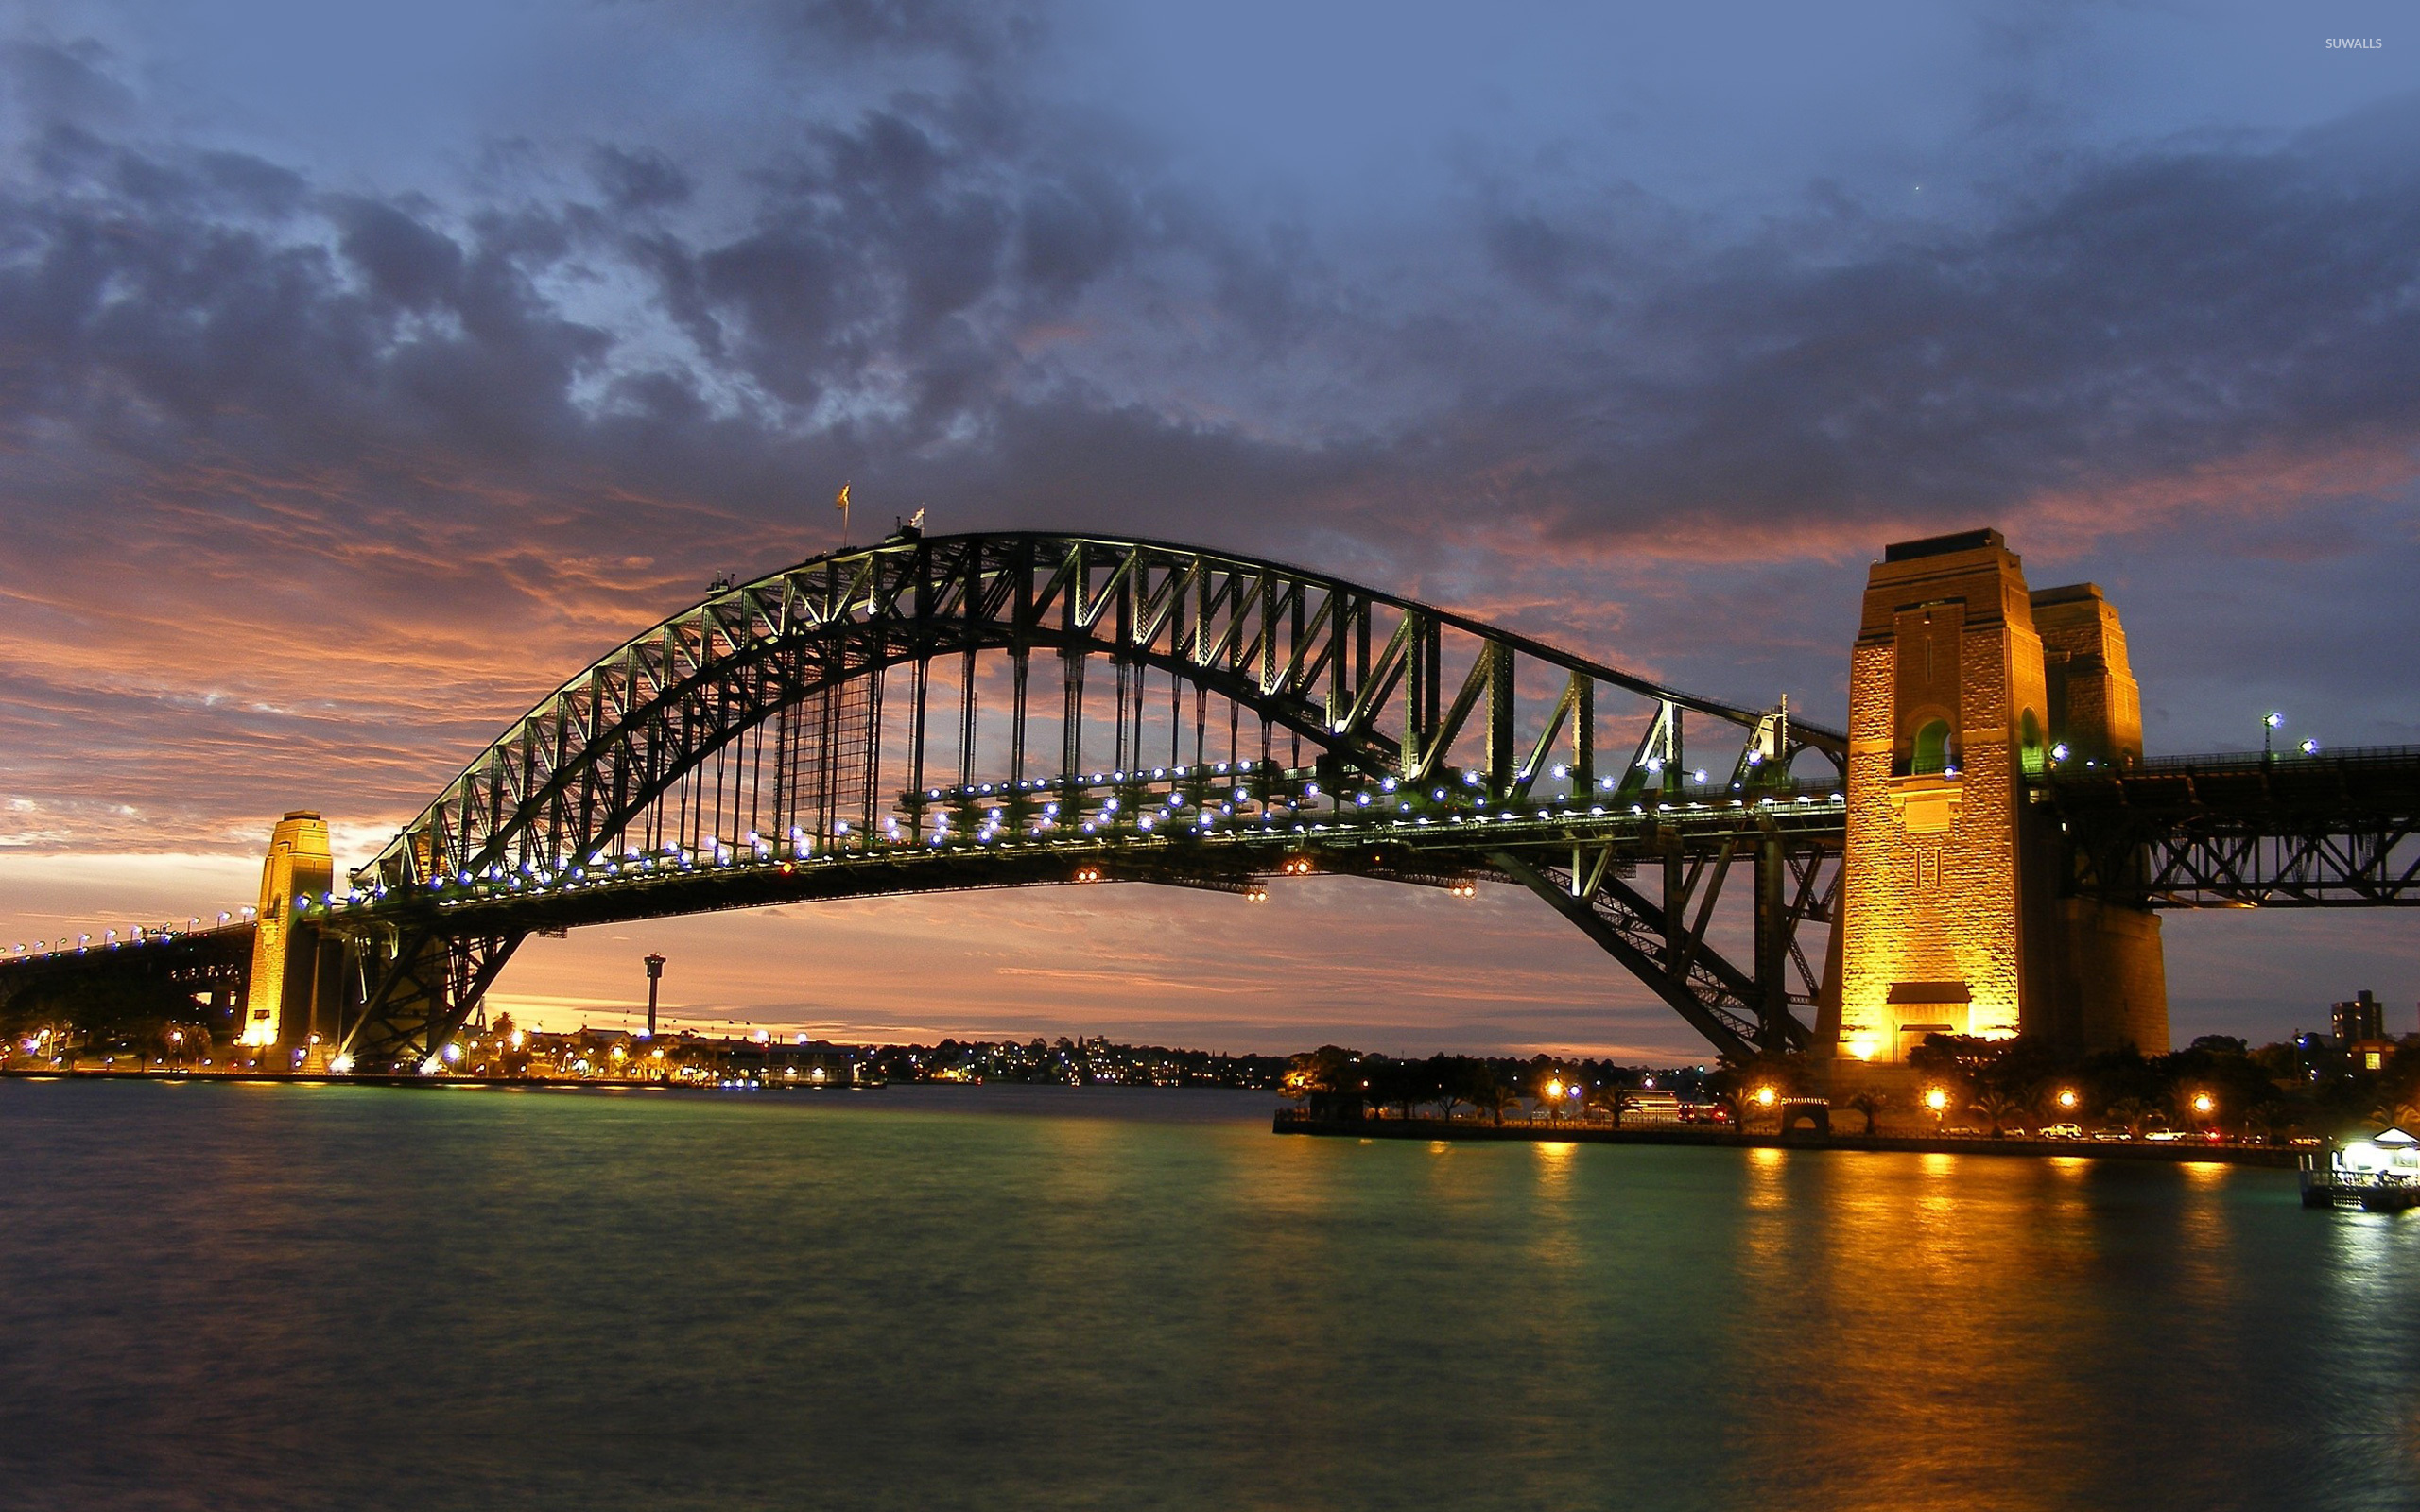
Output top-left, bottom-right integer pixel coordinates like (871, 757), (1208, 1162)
(307, 794), (1846, 934)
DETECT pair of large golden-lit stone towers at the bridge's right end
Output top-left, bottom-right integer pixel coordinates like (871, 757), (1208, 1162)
(1837, 530), (2169, 1062)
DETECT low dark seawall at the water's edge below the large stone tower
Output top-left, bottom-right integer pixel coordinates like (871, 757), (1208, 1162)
(1270, 1108), (2299, 1171)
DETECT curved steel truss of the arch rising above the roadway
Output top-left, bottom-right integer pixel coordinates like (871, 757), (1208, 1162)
(358, 535), (1844, 888)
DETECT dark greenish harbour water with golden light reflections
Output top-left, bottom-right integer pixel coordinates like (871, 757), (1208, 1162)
(0, 1084), (2420, 1512)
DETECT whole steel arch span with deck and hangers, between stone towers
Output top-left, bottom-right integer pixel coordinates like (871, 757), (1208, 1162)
(312, 530), (1846, 1072)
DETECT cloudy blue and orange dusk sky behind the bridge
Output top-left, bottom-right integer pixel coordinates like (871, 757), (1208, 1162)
(0, 0), (2420, 1059)
